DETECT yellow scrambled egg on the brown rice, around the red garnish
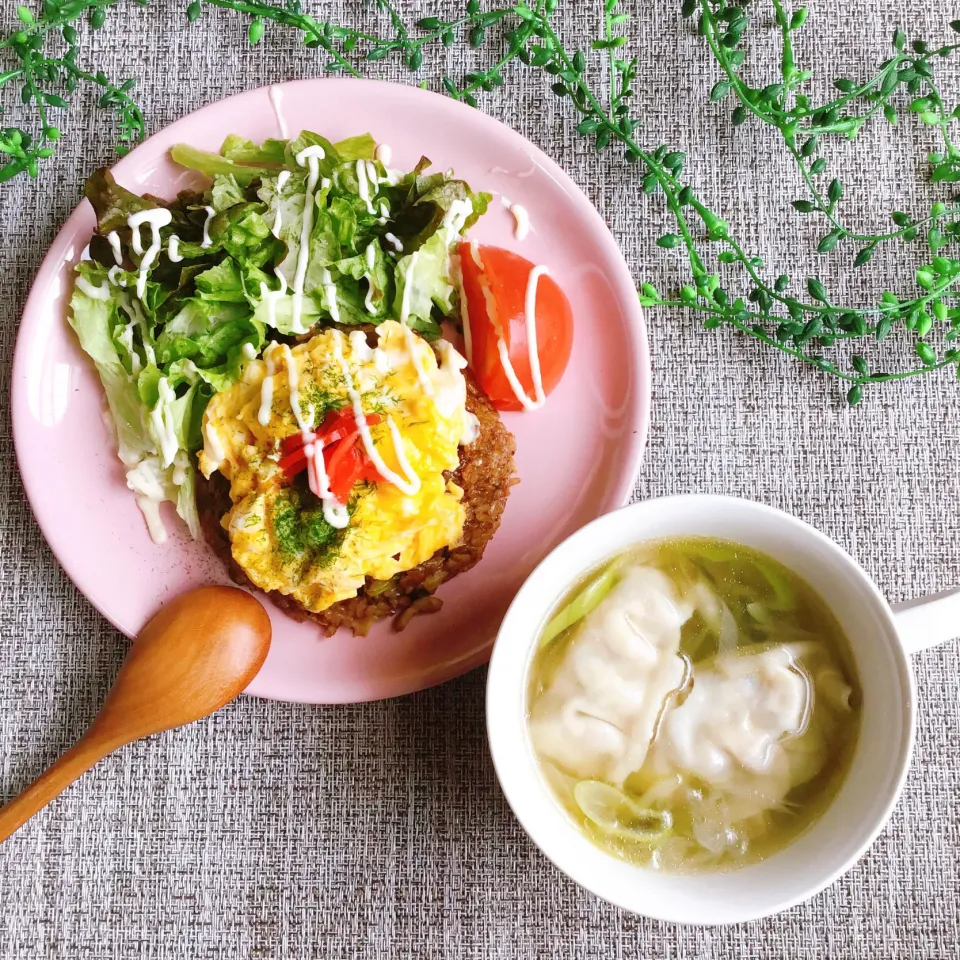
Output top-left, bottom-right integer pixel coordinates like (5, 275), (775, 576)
(199, 320), (472, 612)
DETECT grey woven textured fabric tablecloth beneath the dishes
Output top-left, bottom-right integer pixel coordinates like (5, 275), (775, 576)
(0, 0), (960, 960)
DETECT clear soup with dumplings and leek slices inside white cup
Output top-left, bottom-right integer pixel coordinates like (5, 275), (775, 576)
(528, 538), (860, 871)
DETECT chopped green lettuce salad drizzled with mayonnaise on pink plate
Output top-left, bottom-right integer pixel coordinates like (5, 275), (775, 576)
(69, 132), (490, 540)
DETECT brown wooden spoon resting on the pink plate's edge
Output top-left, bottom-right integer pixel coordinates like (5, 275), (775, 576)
(0, 587), (270, 843)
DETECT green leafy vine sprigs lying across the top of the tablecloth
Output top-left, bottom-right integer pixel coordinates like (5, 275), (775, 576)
(0, 0), (960, 404)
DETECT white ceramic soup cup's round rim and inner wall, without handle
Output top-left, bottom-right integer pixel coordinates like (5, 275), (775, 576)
(487, 496), (920, 924)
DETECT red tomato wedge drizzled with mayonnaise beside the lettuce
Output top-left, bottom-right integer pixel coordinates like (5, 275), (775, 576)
(460, 242), (573, 410)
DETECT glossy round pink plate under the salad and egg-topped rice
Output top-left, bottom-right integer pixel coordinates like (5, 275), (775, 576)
(12, 80), (650, 703)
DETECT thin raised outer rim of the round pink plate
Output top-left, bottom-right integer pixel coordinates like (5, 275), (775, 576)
(9, 77), (652, 704)
